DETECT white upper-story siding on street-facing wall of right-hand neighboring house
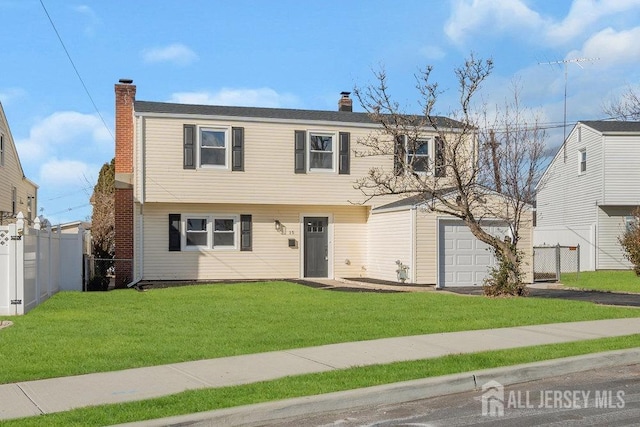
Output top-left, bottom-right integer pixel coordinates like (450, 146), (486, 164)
(602, 135), (640, 205)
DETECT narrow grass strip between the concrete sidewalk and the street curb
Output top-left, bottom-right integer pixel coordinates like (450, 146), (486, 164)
(3, 334), (640, 427)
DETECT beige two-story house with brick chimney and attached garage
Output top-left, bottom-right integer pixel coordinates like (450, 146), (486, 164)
(115, 80), (531, 286)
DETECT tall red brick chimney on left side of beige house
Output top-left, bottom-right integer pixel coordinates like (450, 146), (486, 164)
(115, 79), (136, 288)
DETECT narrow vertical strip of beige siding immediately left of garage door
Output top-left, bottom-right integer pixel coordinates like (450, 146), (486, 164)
(416, 208), (438, 285)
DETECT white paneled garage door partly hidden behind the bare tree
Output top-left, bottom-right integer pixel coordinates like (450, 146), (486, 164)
(438, 220), (508, 287)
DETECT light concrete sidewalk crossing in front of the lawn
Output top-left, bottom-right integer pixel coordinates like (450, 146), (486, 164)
(0, 318), (640, 420)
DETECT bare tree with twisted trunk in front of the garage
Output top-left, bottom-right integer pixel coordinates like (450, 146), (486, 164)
(355, 55), (544, 295)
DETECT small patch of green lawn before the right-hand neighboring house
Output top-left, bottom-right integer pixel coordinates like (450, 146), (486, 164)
(560, 270), (640, 293)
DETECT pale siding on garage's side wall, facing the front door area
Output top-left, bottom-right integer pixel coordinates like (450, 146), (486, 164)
(367, 209), (415, 282)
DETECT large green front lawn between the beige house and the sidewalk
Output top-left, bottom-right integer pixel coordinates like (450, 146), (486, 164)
(0, 282), (640, 383)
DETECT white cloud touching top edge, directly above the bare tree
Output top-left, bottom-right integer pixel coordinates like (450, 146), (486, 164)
(444, 0), (544, 44)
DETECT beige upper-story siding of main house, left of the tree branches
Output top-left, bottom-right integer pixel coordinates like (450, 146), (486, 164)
(138, 117), (393, 205)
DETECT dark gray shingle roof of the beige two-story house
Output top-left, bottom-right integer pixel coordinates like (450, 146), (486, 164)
(134, 101), (461, 128)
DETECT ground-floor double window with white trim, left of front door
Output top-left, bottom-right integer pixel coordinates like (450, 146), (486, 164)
(182, 214), (240, 250)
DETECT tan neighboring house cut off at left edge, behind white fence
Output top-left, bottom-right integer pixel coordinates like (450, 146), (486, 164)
(0, 103), (38, 225)
